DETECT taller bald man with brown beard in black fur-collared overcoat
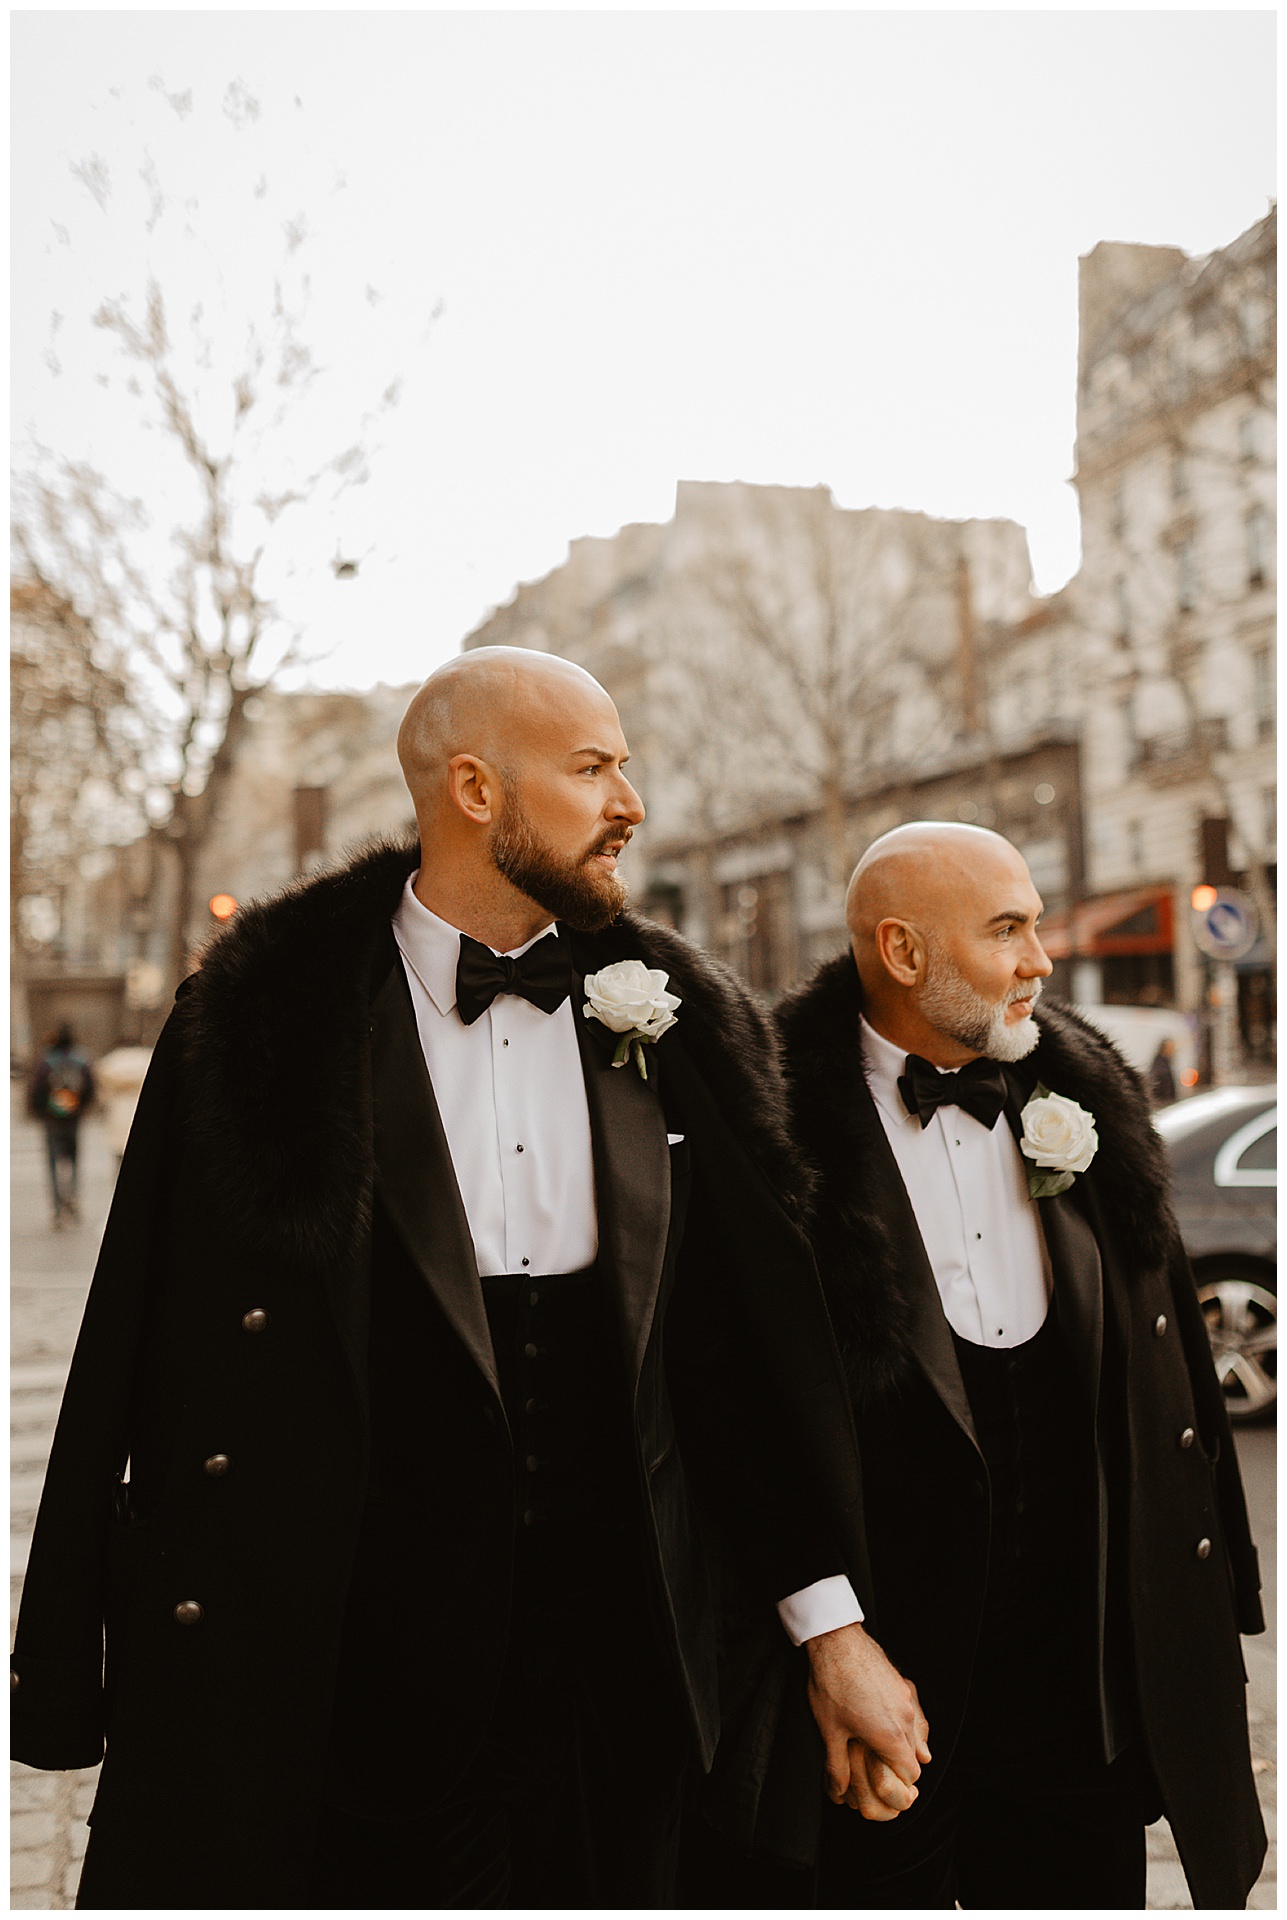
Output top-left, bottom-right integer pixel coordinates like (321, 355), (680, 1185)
(12, 649), (930, 1910)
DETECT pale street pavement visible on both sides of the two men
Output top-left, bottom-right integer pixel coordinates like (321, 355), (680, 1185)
(10, 1089), (1277, 1912)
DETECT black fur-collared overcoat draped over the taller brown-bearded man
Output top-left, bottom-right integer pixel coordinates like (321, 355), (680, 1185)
(13, 847), (862, 1908)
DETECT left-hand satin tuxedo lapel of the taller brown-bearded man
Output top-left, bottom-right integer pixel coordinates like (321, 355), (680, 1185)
(371, 958), (499, 1394)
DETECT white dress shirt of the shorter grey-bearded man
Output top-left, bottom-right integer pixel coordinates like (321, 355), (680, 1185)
(862, 1020), (1051, 1346)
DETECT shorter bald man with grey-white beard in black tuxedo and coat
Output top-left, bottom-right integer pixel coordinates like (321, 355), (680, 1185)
(780, 824), (1266, 1910)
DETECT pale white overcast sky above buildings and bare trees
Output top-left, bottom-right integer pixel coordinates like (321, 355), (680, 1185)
(12, 10), (1275, 685)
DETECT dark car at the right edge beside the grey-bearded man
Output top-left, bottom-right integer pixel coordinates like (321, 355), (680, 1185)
(1153, 1087), (1277, 1423)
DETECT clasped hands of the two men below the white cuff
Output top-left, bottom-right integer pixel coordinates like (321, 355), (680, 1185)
(805, 1620), (930, 1820)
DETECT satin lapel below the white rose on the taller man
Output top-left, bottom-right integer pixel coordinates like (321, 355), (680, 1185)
(572, 983), (670, 1384)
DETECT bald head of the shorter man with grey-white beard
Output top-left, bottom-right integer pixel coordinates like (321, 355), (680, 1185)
(845, 820), (1051, 1068)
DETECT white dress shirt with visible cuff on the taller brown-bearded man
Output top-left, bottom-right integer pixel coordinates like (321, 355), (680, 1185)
(394, 883), (862, 1645)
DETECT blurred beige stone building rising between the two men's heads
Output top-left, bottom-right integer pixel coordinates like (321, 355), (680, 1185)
(465, 482), (1080, 993)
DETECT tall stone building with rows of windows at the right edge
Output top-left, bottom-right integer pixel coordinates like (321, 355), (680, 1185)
(1072, 213), (1277, 1058)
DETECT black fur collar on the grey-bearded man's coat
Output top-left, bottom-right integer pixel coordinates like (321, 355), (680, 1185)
(778, 952), (1176, 1402)
